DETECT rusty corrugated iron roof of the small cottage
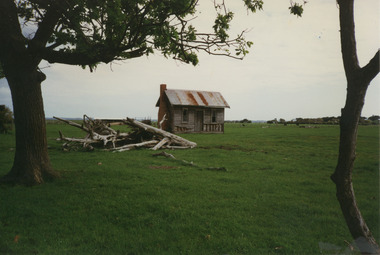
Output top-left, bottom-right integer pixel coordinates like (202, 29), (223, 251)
(165, 89), (230, 108)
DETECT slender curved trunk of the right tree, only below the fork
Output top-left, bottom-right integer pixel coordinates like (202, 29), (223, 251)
(331, 79), (380, 254)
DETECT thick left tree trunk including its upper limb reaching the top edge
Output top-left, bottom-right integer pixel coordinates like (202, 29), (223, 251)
(0, 0), (59, 185)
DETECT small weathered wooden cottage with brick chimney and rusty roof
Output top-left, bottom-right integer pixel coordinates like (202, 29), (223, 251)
(156, 84), (230, 133)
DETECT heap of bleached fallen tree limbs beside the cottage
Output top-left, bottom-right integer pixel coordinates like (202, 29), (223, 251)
(53, 115), (197, 152)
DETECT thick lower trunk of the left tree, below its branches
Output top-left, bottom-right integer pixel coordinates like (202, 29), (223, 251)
(1, 65), (59, 185)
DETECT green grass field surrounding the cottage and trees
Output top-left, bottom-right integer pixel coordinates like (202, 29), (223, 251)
(0, 124), (380, 254)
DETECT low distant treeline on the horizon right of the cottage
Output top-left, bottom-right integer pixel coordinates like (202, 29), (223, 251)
(226, 115), (380, 125)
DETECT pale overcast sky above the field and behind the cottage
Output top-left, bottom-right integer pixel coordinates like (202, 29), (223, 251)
(0, 0), (380, 120)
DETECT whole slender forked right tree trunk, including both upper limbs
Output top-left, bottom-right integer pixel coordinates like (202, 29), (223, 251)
(331, 0), (380, 254)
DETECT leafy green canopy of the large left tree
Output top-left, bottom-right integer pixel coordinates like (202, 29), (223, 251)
(2, 0), (255, 69)
